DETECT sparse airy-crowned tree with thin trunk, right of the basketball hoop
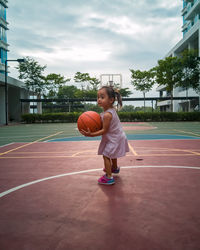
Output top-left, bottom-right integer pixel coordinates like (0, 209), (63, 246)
(130, 69), (155, 111)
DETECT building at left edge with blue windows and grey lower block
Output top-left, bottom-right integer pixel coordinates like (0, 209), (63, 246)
(0, 0), (29, 125)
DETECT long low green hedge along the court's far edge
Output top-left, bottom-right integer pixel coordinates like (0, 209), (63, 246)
(22, 112), (200, 123)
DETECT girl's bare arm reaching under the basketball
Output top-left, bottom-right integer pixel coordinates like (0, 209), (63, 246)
(81, 112), (112, 137)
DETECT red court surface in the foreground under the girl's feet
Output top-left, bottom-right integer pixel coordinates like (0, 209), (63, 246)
(0, 140), (200, 250)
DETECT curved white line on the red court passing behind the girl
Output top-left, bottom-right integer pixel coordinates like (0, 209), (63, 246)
(0, 166), (200, 198)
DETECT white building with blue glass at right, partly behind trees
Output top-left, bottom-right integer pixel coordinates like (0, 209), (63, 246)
(157, 0), (200, 112)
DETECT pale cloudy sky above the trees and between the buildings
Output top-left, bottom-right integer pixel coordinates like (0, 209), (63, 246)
(7, 0), (182, 99)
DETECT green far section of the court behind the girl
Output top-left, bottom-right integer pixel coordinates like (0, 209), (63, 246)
(0, 122), (200, 146)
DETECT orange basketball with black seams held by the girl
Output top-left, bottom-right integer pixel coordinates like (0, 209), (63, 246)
(77, 111), (102, 132)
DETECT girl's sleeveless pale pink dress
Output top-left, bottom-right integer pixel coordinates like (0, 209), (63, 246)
(98, 108), (129, 159)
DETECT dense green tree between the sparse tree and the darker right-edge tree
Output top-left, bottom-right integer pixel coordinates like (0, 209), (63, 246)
(152, 57), (181, 111)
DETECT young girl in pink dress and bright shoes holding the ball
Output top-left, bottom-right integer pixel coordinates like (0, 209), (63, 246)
(81, 86), (129, 185)
